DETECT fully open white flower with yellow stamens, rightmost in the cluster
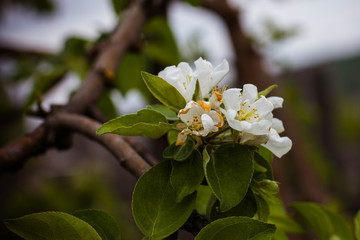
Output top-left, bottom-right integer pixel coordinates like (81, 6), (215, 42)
(223, 84), (292, 157)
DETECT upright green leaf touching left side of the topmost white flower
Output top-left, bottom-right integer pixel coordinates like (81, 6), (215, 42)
(141, 72), (186, 112)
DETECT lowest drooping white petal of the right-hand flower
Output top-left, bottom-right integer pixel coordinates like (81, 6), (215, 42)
(262, 128), (292, 158)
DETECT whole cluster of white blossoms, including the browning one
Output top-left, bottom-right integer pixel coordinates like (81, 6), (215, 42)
(159, 58), (292, 157)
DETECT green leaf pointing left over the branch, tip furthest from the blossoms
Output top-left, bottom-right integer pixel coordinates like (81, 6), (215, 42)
(96, 109), (171, 138)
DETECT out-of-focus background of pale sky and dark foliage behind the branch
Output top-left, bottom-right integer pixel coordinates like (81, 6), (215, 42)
(0, 0), (360, 240)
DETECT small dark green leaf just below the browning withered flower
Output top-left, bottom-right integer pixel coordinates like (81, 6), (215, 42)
(163, 138), (195, 161)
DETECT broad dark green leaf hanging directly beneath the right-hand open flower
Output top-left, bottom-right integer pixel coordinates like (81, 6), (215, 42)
(203, 143), (254, 212)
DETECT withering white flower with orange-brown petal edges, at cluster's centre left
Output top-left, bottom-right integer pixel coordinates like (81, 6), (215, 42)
(176, 101), (224, 145)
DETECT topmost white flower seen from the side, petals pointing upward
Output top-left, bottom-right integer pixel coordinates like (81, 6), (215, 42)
(158, 58), (229, 102)
